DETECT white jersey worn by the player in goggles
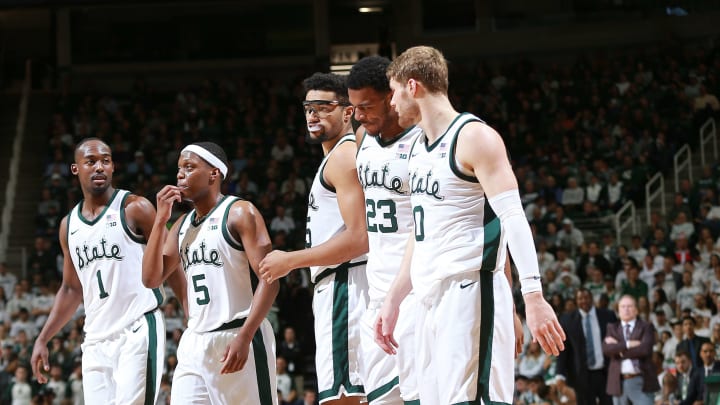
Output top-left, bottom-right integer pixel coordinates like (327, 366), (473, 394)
(305, 134), (366, 283)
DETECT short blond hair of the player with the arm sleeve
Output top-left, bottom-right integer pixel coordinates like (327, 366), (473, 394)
(387, 46), (448, 94)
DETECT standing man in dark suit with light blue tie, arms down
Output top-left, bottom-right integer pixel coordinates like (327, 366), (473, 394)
(556, 288), (617, 405)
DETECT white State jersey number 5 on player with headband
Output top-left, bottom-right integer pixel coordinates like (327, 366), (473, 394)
(178, 196), (253, 333)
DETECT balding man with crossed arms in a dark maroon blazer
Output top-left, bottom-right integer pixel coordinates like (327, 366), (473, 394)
(603, 295), (660, 405)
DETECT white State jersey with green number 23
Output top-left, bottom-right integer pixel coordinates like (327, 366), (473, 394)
(356, 127), (422, 300)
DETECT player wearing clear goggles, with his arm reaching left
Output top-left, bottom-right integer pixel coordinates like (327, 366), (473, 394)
(260, 73), (368, 404)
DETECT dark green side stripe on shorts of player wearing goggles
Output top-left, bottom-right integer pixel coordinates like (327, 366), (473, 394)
(318, 265), (365, 401)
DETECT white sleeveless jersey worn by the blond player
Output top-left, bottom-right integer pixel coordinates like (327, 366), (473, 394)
(408, 113), (506, 299)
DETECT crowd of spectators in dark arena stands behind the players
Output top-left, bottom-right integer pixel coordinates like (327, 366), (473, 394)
(0, 34), (720, 404)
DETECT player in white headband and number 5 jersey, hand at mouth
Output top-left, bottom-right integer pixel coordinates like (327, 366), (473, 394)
(143, 142), (279, 405)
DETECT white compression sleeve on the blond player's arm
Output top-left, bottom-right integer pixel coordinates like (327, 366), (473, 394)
(488, 189), (542, 295)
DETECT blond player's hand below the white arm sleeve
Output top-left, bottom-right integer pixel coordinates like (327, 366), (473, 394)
(523, 291), (565, 356)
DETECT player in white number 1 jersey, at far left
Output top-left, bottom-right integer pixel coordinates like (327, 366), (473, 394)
(30, 138), (184, 404)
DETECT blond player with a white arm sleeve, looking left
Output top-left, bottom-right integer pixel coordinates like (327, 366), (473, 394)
(376, 47), (564, 404)
